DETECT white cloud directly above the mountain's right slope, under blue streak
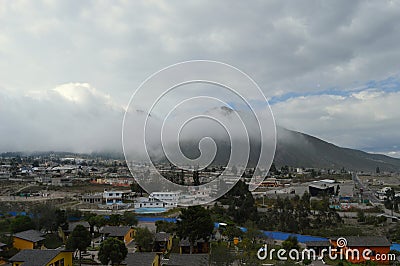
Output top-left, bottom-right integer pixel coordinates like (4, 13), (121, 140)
(272, 89), (400, 156)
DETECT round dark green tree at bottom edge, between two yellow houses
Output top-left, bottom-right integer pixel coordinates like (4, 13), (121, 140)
(98, 238), (128, 265)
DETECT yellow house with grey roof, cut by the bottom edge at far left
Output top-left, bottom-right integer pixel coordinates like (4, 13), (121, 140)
(9, 249), (73, 266)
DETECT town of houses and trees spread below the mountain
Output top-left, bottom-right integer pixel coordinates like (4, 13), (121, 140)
(0, 153), (400, 266)
